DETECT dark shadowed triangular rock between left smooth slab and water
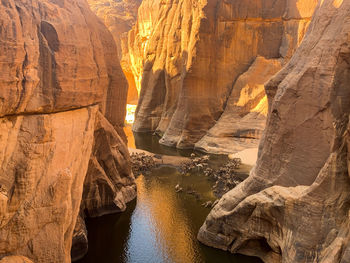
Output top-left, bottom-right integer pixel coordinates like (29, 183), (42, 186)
(81, 114), (136, 217)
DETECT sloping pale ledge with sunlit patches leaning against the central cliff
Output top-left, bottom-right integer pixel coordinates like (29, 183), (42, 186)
(195, 57), (282, 154)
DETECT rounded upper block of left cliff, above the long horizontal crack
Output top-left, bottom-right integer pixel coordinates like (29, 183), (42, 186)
(0, 0), (127, 125)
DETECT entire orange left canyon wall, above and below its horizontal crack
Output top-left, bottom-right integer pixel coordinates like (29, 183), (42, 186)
(0, 0), (135, 263)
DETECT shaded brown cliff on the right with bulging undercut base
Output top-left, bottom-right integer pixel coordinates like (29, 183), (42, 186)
(198, 0), (350, 263)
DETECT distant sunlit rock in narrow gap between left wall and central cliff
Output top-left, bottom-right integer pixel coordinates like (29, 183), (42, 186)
(88, 0), (141, 104)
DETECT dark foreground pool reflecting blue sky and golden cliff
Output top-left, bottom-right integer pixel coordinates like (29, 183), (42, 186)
(79, 130), (261, 263)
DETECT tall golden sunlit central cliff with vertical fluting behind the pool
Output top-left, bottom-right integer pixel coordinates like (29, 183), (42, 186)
(129, 0), (317, 148)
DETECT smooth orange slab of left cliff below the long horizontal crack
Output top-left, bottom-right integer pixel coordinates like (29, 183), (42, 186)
(0, 107), (97, 262)
